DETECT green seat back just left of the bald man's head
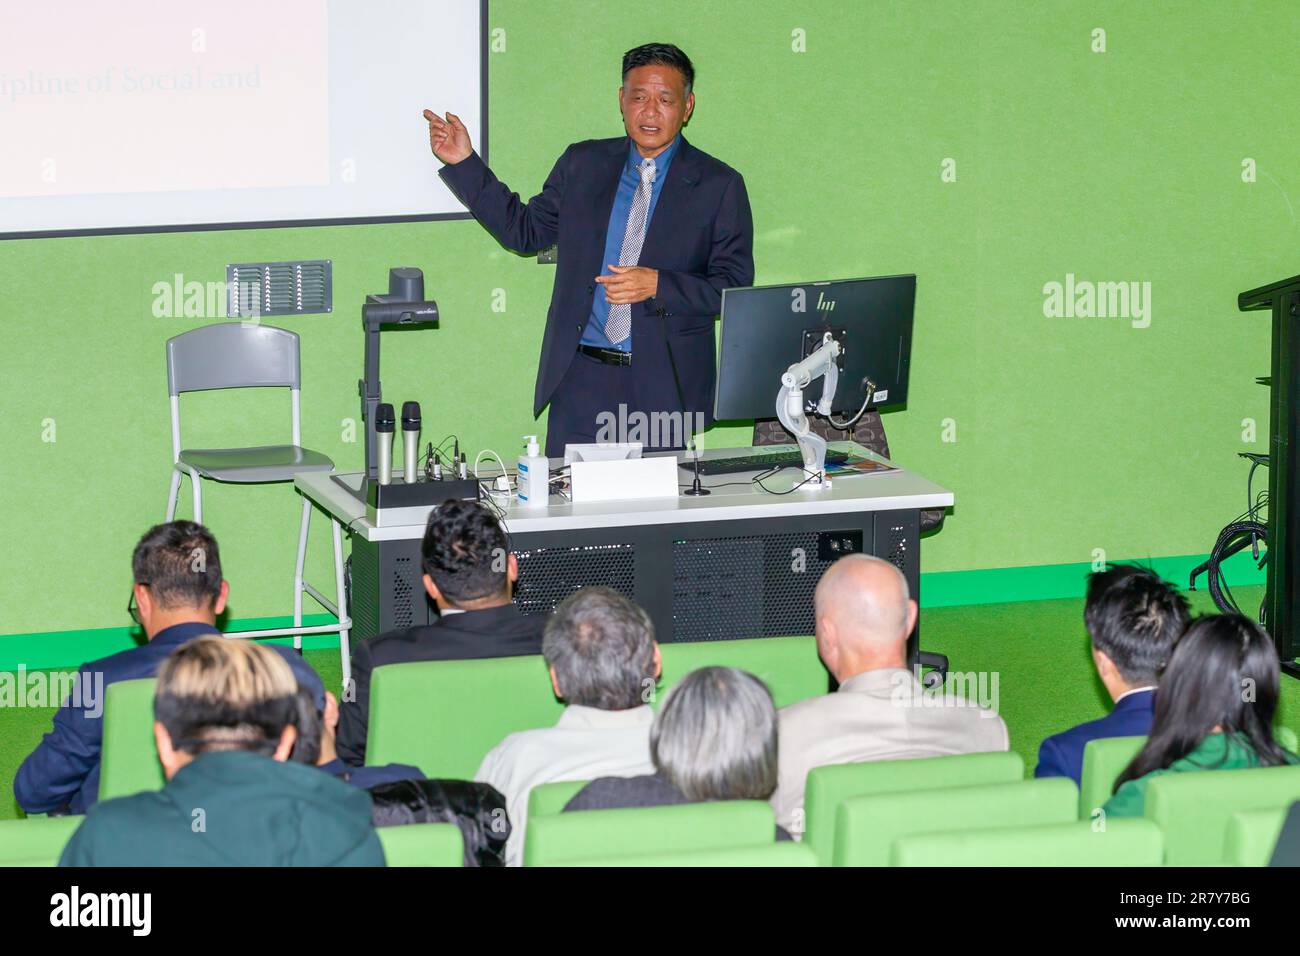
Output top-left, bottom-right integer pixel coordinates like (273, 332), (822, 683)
(658, 637), (831, 708)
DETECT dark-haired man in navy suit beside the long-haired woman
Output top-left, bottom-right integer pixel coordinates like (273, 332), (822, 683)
(1034, 564), (1188, 783)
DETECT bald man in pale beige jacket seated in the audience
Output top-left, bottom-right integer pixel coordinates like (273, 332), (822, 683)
(771, 554), (1009, 836)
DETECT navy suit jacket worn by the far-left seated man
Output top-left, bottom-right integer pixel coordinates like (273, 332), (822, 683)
(13, 622), (325, 813)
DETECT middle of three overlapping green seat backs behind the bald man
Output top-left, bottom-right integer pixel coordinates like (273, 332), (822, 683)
(833, 777), (1079, 866)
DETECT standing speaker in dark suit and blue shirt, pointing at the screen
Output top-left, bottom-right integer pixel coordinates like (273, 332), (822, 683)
(424, 43), (754, 458)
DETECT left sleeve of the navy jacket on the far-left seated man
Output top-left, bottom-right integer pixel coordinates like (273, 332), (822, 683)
(13, 671), (103, 813)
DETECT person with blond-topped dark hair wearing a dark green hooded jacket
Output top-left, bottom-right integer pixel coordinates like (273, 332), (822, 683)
(59, 637), (384, 866)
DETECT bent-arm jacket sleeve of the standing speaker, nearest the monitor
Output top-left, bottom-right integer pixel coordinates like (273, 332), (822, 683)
(650, 173), (754, 316)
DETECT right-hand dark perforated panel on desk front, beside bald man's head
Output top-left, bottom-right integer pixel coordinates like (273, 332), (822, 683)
(672, 531), (831, 641)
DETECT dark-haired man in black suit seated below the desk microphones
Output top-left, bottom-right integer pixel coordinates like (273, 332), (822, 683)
(334, 499), (546, 766)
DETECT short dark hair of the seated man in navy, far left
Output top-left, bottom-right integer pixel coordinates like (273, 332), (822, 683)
(131, 522), (221, 607)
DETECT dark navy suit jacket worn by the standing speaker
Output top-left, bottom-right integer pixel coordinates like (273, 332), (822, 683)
(438, 137), (754, 423)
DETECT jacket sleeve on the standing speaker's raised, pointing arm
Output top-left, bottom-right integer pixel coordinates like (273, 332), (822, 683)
(438, 147), (572, 255)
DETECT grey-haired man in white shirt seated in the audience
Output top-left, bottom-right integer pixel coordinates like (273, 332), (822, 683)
(475, 588), (662, 866)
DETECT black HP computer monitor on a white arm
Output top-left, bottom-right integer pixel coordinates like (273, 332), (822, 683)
(714, 276), (917, 420)
